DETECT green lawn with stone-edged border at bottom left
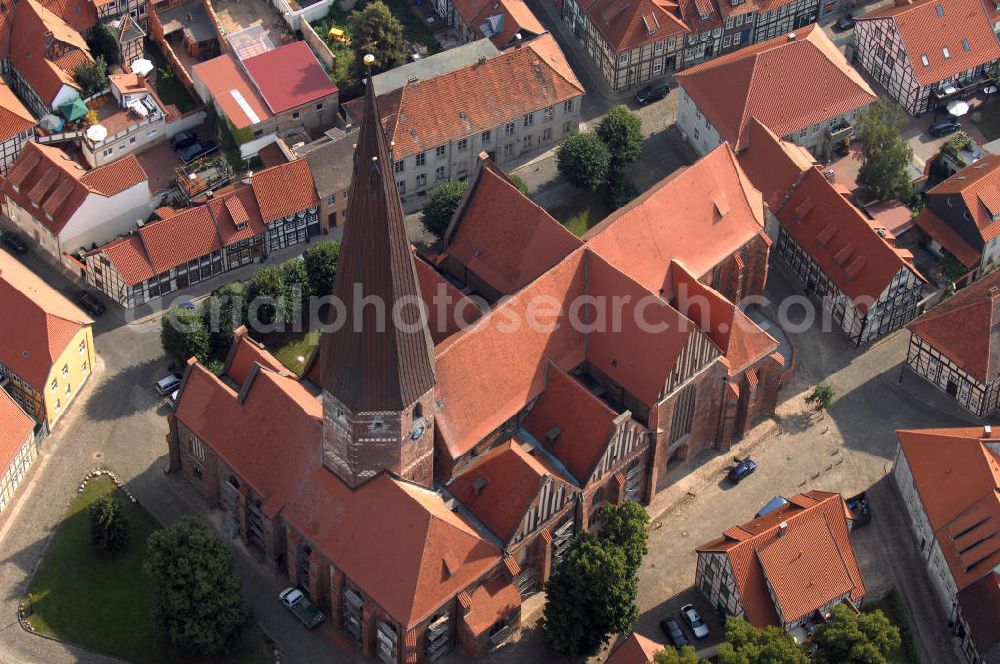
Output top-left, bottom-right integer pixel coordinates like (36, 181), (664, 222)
(28, 476), (271, 664)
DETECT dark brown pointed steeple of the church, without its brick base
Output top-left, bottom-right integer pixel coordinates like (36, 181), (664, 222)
(321, 76), (434, 413)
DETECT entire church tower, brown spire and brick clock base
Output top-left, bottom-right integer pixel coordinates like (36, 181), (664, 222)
(320, 77), (434, 488)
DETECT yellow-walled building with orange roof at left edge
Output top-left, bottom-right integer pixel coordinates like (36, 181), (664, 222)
(0, 252), (95, 431)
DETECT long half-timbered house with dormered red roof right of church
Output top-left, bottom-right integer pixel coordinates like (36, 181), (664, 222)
(739, 115), (925, 345)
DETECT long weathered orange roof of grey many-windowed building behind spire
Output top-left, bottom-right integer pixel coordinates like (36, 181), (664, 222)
(344, 34), (584, 160)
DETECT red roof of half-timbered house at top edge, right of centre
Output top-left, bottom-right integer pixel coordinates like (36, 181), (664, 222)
(583, 0), (690, 53)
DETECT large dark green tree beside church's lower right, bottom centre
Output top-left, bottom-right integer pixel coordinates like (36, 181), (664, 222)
(542, 532), (639, 656)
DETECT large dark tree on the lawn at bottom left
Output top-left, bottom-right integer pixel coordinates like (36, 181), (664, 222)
(144, 516), (253, 655)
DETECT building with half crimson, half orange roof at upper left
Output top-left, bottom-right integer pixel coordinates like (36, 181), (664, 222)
(191, 41), (337, 159)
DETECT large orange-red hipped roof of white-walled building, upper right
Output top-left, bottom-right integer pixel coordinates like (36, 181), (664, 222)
(676, 24), (876, 150)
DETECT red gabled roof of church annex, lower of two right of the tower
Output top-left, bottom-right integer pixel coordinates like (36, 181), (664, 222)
(448, 438), (573, 544)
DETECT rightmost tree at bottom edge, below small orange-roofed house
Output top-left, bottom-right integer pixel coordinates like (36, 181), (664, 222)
(813, 604), (901, 664)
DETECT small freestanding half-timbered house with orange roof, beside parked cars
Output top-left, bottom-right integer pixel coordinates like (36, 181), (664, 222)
(695, 491), (866, 641)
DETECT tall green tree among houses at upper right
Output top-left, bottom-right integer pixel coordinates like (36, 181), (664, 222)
(857, 98), (913, 201)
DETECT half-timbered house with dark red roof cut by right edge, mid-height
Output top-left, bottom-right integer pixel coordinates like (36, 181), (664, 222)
(906, 272), (1000, 417)
